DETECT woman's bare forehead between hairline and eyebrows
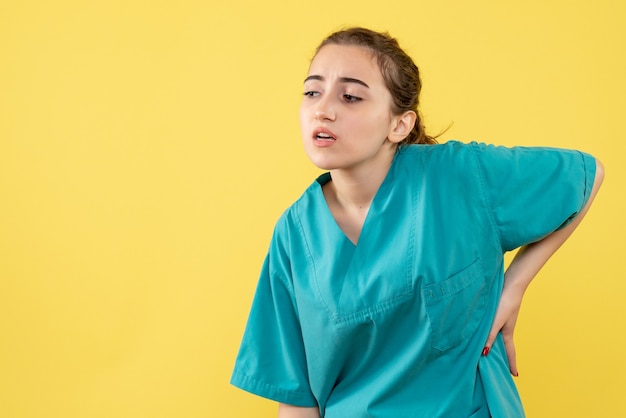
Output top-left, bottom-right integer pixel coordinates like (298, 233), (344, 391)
(309, 44), (382, 81)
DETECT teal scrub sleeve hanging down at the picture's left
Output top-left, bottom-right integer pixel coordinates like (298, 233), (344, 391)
(231, 224), (317, 407)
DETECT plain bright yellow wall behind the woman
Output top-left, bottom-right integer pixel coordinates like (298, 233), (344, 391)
(0, 0), (626, 418)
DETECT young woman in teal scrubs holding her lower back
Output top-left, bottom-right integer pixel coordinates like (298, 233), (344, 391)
(231, 28), (603, 418)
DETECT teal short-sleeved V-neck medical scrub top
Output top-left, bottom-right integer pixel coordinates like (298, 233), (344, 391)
(231, 142), (595, 418)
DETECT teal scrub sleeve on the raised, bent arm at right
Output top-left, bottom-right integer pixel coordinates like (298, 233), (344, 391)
(471, 143), (596, 251)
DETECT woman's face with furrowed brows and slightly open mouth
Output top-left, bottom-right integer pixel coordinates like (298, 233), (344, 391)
(300, 44), (399, 170)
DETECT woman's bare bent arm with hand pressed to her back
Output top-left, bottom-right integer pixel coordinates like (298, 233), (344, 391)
(483, 160), (604, 376)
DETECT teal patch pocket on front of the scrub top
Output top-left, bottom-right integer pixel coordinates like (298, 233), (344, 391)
(422, 259), (488, 351)
